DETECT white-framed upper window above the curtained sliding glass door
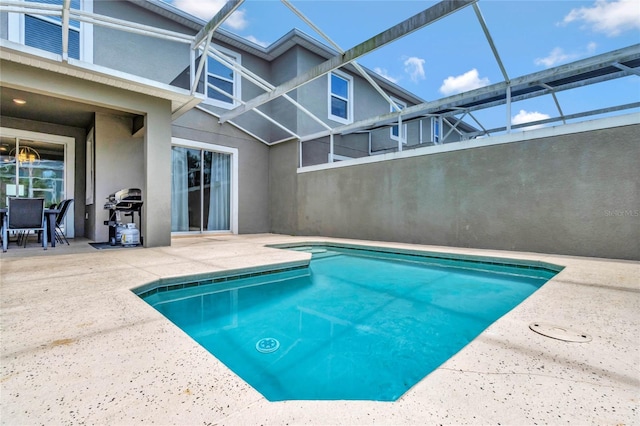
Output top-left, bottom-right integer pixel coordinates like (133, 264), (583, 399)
(192, 46), (241, 109)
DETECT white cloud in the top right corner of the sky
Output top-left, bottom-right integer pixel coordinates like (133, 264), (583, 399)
(562, 0), (640, 37)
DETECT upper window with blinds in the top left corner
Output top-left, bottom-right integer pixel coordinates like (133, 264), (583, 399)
(8, 0), (93, 62)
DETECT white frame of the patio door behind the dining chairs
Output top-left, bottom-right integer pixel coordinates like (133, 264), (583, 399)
(0, 127), (77, 238)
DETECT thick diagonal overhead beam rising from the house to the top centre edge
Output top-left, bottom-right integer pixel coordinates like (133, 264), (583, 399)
(220, 0), (477, 123)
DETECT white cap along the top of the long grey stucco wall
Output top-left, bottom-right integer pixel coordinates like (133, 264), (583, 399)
(297, 112), (640, 173)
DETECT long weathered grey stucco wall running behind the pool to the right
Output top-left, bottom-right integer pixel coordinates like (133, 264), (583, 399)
(271, 120), (640, 259)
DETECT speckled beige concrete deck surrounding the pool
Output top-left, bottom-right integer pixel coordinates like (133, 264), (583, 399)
(0, 234), (640, 425)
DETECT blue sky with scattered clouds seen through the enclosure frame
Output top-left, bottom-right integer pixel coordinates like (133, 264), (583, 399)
(165, 0), (640, 131)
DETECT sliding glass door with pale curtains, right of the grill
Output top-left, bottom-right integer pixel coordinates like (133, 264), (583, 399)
(171, 146), (232, 233)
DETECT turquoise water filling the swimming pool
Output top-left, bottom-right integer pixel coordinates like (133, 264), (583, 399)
(141, 247), (557, 401)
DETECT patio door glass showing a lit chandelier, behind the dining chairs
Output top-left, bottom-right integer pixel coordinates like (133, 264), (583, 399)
(0, 136), (65, 207)
